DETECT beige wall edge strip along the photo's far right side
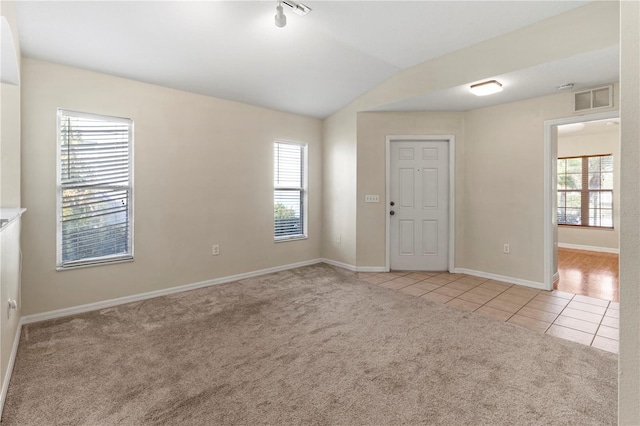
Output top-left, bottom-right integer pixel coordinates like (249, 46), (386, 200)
(618, 1), (640, 426)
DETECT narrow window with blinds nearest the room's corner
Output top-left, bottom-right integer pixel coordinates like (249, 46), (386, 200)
(273, 142), (307, 241)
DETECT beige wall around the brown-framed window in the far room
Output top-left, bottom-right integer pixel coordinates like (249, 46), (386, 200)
(558, 124), (620, 250)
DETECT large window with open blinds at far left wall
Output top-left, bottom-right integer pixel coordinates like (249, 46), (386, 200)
(57, 109), (133, 269)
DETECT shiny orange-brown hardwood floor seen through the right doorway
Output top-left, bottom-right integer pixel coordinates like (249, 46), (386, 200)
(553, 248), (620, 302)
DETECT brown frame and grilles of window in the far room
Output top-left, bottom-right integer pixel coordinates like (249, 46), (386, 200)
(556, 153), (615, 230)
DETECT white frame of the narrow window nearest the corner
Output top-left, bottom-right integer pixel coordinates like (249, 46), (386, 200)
(271, 139), (309, 243)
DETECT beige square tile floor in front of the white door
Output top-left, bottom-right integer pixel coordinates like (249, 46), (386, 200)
(358, 271), (620, 353)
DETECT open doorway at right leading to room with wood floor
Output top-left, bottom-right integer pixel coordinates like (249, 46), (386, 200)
(544, 111), (620, 302)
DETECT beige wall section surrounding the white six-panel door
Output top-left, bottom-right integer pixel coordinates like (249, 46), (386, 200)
(357, 112), (465, 268)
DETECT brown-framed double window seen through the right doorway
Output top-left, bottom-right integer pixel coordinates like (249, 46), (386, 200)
(558, 155), (613, 228)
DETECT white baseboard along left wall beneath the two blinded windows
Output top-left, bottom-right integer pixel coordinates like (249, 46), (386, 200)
(22, 259), (323, 324)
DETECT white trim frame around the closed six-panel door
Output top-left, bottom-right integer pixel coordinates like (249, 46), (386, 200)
(384, 135), (456, 272)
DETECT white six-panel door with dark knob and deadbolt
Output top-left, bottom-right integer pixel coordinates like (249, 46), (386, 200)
(388, 141), (449, 271)
